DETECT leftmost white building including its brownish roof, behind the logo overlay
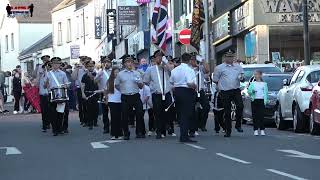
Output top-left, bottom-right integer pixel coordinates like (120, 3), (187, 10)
(0, 0), (61, 71)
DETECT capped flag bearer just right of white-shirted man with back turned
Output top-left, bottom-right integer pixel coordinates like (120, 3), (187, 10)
(190, 54), (210, 131)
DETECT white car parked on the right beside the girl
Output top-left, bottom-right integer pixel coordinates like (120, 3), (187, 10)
(275, 65), (320, 132)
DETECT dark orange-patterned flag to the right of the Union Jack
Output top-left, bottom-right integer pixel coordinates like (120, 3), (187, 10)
(190, 0), (205, 51)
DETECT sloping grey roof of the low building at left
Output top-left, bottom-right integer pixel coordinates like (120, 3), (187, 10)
(19, 33), (53, 59)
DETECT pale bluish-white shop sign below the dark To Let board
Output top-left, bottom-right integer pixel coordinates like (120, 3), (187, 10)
(128, 31), (144, 55)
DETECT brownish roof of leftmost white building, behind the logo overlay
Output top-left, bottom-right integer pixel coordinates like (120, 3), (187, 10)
(9, 0), (62, 23)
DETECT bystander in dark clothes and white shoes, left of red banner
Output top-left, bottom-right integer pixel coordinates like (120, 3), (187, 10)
(12, 70), (22, 114)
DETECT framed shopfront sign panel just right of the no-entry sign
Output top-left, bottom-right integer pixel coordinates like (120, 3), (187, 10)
(212, 12), (230, 45)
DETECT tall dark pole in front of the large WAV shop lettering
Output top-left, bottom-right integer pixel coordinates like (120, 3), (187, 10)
(303, 0), (310, 65)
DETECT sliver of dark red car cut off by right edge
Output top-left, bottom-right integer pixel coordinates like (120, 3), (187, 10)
(309, 81), (320, 135)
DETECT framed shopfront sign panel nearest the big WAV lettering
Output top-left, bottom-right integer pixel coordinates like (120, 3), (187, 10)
(232, 0), (254, 35)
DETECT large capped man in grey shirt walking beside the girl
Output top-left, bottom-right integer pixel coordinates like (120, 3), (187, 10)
(212, 51), (244, 137)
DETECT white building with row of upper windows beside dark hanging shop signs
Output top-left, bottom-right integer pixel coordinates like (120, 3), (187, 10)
(52, 0), (105, 64)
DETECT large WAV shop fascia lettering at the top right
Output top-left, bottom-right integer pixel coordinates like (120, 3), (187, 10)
(260, 0), (320, 23)
